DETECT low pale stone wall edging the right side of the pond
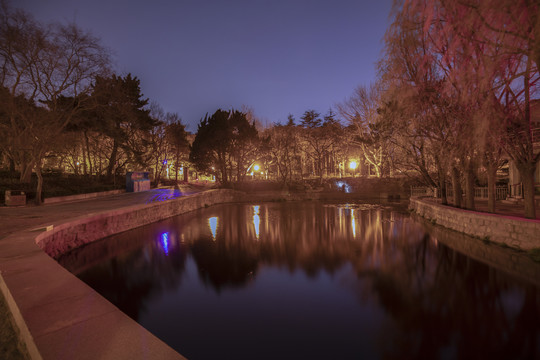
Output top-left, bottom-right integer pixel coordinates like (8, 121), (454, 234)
(409, 198), (540, 250)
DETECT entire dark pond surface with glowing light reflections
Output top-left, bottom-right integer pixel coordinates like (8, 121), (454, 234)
(60, 202), (540, 360)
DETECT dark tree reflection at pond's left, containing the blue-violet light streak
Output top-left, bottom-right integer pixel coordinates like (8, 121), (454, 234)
(71, 227), (187, 320)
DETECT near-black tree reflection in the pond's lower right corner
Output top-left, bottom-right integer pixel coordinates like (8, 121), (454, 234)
(367, 237), (540, 359)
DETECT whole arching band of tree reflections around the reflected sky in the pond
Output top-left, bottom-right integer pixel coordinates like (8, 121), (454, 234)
(67, 202), (540, 359)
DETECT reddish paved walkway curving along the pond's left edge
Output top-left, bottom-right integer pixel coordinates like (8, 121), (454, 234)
(0, 187), (207, 360)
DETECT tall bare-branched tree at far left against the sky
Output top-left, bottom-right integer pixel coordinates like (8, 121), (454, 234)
(0, 3), (109, 203)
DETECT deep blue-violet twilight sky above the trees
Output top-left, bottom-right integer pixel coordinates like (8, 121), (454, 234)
(15, 0), (392, 132)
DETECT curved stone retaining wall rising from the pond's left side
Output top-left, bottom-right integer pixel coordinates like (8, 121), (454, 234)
(35, 189), (239, 257)
